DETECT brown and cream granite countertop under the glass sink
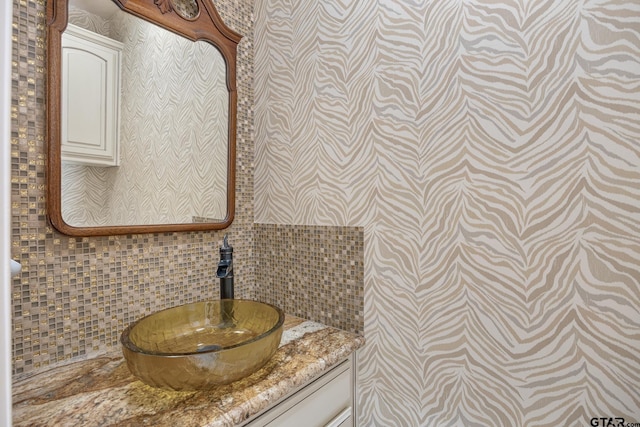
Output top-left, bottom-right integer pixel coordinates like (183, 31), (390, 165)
(13, 316), (364, 427)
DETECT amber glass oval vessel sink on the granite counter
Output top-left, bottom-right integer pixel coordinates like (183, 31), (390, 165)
(120, 299), (284, 390)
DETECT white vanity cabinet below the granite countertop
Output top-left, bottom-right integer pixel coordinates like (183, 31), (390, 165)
(243, 354), (356, 427)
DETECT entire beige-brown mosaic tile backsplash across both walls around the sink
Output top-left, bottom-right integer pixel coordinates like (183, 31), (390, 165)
(11, 0), (363, 375)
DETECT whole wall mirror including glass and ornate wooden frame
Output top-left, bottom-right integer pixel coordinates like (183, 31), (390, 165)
(47, 0), (241, 236)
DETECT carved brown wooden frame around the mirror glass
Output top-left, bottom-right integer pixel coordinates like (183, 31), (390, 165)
(47, 0), (241, 236)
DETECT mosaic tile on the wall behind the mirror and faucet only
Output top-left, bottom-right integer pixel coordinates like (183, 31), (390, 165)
(11, 0), (254, 374)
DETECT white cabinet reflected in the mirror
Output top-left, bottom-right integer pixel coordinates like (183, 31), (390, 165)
(61, 24), (123, 166)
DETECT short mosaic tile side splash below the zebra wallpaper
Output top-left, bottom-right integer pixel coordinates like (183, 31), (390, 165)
(255, 224), (364, 334)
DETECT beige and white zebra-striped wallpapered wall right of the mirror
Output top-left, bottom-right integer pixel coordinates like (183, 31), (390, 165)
(255, 0), (640, 426)
